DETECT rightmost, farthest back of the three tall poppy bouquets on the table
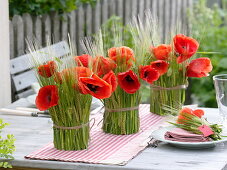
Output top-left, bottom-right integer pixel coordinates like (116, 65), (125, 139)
(131, 13), (212, 115)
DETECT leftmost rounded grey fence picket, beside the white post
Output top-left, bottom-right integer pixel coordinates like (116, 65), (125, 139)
(12, 15), (25, 56)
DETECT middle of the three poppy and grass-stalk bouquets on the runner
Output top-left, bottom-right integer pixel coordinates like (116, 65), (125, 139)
(83, 31), (151, 135)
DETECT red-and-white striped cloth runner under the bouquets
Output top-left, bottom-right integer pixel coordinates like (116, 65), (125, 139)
(25, 104), (165, 165)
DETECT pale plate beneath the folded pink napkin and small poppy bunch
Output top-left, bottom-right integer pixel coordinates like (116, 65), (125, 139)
(151, 126), (227, 149)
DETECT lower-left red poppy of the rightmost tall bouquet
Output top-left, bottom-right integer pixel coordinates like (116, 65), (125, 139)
(139, 65), (159, 84)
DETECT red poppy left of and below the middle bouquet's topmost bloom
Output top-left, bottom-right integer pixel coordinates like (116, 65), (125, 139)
(93, 56), (117, 76)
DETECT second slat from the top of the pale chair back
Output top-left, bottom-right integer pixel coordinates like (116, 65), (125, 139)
(12, 70), (37, 91)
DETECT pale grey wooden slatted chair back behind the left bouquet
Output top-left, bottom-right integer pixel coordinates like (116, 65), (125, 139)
(10, 41), (70, 100)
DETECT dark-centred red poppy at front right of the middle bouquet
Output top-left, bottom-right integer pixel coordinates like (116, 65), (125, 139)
(117, 70), (140, 94)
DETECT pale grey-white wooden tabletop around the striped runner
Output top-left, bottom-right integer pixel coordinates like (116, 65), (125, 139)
(0, 101), (227, 170)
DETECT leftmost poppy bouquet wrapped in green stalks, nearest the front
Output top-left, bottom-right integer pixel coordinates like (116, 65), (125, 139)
(29, 40), (112, 150)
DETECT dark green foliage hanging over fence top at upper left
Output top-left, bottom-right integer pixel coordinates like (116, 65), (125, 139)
(9, 0), (97, 17)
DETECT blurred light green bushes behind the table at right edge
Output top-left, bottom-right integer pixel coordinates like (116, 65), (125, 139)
(188, 0), (227, 107)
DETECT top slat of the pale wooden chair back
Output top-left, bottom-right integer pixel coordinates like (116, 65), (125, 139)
(10, 41), (70, 74)
